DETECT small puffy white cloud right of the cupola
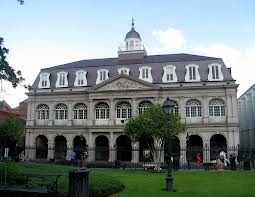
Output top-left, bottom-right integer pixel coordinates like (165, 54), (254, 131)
(152, 27), (186, 50)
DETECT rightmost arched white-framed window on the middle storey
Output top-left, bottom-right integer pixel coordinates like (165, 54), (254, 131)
(209, 99), (225, 116)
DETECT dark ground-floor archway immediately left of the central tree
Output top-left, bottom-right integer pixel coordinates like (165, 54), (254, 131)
(116, 135), (132, 161)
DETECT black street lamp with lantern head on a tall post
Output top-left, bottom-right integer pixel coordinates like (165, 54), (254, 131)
(162, 97), (175, 192)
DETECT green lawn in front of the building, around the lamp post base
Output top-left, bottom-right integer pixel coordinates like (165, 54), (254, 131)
(11, 164), (255, 197)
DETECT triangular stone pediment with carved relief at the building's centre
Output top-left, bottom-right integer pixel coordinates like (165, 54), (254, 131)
(92, 75), (154, 91)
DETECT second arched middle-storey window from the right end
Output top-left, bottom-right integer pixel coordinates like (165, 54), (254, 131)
(186, 99), (202, 117)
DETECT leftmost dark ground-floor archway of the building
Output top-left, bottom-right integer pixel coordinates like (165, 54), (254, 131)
(35, 135), (48, 159)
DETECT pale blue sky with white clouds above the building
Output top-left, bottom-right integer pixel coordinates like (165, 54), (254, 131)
(0, 0), (255, 107)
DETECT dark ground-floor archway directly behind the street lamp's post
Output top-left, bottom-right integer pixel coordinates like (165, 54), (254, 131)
(164, 136), (181, 169)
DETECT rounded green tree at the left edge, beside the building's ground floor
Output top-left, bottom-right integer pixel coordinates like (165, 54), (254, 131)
(0, 117), (24, 140)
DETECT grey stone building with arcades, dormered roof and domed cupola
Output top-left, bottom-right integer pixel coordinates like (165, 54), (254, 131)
(26, 20), (239, 162)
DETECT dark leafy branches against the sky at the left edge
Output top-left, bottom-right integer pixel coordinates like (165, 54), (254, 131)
(0, 37), (24, 88)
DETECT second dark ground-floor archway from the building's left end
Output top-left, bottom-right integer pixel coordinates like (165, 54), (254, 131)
(54, 136), (67, 160)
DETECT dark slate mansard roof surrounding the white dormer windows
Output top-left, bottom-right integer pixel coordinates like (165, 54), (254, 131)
(32, 53), (234, 89)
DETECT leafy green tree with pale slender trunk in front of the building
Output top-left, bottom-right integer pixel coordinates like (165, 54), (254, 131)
(124, 104), (185, 170)
